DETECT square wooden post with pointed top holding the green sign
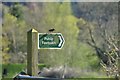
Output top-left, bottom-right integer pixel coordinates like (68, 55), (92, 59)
(27, 29), (38, 76)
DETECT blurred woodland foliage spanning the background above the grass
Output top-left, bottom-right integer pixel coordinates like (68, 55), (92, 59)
(2, 2), (117, 78)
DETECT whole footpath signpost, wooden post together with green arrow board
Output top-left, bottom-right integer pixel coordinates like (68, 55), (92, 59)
(26, 29), (65, 76)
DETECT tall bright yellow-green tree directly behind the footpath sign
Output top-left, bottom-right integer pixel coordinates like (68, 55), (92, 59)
(38, 3), (78, 65)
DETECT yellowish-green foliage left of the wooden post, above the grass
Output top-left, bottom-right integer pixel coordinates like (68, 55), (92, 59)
(2, 7), (26, 62)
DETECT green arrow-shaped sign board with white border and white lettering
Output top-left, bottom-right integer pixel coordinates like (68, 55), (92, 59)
(38, 33), (65, 49)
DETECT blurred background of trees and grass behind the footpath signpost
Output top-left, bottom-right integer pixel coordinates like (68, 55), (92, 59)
(1, 2), (120, 78)
